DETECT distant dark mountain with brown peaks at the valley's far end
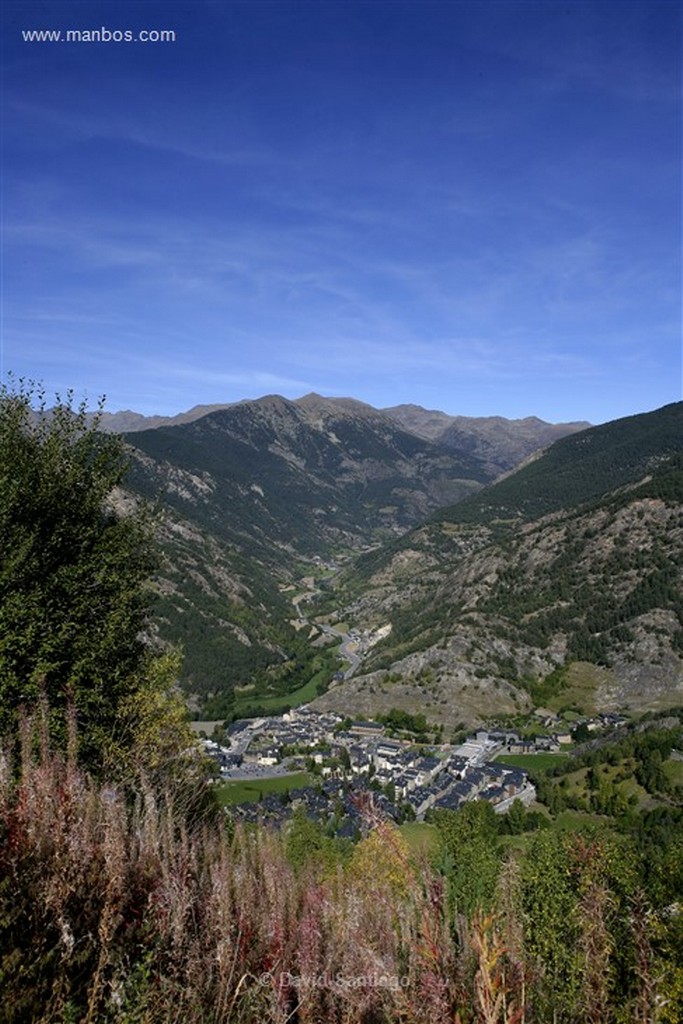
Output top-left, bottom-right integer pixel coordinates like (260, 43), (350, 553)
(128, 395), (489, 561)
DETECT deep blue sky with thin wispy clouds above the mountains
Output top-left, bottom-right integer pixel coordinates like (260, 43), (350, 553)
(1, 0), (681, 423)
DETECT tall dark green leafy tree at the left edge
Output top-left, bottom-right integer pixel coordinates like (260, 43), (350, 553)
(0, 380), (191, 767)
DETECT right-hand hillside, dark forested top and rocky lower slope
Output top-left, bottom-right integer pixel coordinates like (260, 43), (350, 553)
(321, 403), (683, 725)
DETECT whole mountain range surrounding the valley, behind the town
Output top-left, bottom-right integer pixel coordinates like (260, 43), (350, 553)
(120, 394), (683, 725)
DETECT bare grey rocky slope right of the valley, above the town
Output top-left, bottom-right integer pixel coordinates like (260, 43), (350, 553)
(329, 487), (683, 724)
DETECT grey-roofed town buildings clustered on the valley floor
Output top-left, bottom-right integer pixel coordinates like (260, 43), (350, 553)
(205, 707), (548, 836)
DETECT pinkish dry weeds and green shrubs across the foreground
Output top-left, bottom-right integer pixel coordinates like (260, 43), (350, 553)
(0, 722), (683, 1024)
